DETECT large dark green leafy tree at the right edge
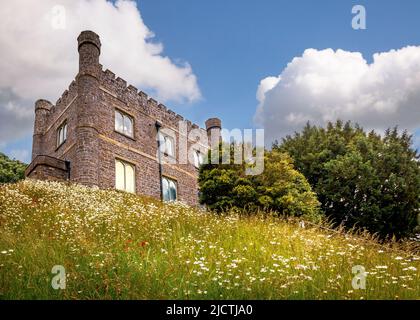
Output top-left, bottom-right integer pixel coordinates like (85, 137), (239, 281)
(273, 121), (420, 238)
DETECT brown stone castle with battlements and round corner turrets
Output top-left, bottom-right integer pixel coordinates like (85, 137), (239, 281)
(26, 31), (221, 205)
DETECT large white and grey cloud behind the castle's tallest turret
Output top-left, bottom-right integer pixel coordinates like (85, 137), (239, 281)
(0, 0), (200, 144)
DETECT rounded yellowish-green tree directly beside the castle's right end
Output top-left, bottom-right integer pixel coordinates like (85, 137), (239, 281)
(199, 145), (320, 220)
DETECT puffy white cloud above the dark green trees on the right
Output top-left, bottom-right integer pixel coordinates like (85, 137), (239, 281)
(254, 46), (420, 142)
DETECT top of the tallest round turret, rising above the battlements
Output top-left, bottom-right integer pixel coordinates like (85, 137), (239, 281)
(77, 31), (101, 72)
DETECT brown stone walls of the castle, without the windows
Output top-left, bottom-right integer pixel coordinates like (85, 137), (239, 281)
(28, 31), (220, 205)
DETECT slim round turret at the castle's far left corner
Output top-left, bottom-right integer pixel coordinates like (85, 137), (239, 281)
(32, 99), (52, 160)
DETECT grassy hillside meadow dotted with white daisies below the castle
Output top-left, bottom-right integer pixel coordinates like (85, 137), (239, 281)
(0, 180), (420, 299)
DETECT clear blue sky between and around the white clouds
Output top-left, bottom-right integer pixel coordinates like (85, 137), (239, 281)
(2, 0), (420, 160)
